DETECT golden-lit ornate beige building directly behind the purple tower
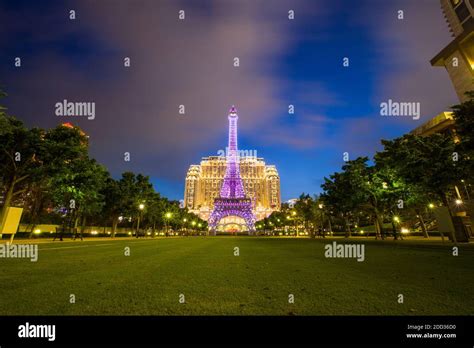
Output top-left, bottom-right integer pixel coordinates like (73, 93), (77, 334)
(184, 156), (281, 220)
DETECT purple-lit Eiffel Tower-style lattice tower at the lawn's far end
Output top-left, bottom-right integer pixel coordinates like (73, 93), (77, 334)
(208, 106), (255, 234)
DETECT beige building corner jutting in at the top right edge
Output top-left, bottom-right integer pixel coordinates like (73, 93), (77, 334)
(431, 0), (474, 102)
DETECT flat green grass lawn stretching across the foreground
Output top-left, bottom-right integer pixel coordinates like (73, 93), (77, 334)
(0, 237), (474, 315)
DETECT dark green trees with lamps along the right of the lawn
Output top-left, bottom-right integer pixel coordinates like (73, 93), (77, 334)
(260, 92), (474, 241)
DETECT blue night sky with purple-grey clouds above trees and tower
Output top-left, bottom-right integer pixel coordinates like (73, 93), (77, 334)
(0, 0), (457, 200)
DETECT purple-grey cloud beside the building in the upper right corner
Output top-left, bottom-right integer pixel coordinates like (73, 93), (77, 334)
(357, 0), (458, 125)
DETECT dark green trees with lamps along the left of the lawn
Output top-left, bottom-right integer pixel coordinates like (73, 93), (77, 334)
(0, 93), (207, 236)
